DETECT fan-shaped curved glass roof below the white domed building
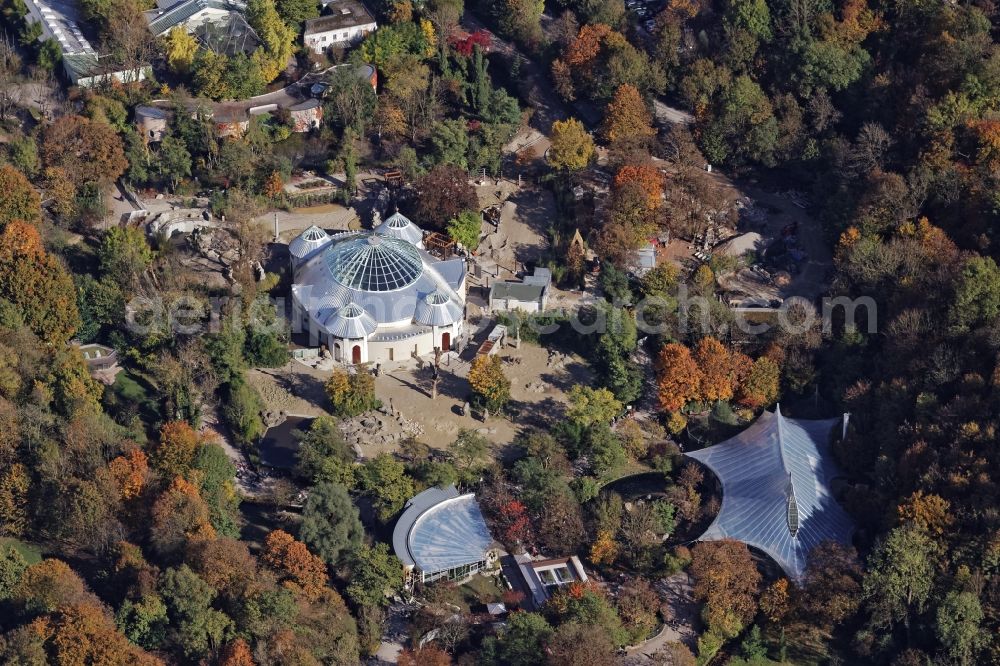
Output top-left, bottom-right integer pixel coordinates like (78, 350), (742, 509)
(392, 486), (493, 574)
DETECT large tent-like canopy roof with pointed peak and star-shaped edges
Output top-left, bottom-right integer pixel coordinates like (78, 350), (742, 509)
(687, 406), (854, 580)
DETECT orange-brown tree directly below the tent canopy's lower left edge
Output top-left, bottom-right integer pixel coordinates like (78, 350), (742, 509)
(690, 539), (761, 636)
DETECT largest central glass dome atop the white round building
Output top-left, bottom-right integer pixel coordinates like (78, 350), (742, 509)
(324, 233), (424, 291)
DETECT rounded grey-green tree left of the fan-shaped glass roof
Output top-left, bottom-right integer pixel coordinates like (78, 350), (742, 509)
(299, 482), (364, 565)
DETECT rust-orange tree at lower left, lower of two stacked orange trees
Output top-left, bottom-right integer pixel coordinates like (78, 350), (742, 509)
(149, 476), (215, 555)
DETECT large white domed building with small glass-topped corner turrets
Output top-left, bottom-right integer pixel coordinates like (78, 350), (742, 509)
(288, 223), (466, 365)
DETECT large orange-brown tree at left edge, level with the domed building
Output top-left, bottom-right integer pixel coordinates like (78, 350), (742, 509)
(0, 220), (80, 347)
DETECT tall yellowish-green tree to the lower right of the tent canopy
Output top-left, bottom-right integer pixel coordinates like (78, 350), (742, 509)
(864, 526), (935, 628)
